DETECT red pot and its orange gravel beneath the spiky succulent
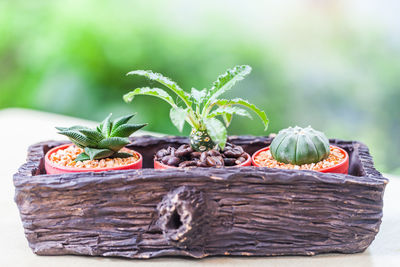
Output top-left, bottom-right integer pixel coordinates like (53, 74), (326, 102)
(45, 144), (142, 174)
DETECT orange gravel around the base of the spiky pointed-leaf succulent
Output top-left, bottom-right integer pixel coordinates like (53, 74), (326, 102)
(49, 145), (139, 168)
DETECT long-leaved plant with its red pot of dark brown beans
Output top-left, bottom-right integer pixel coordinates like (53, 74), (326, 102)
(124, 65), (268, 169)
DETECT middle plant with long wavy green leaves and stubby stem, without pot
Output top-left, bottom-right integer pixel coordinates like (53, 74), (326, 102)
(123, 65), (268, 151)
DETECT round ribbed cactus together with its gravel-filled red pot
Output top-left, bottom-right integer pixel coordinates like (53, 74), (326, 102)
(252, 126), (349, 174)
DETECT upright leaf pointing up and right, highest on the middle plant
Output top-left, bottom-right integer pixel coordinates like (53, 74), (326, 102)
(207, 65), (251, 102)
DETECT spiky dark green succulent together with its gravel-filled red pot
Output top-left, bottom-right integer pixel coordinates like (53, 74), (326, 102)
(45, 114), (147, 174)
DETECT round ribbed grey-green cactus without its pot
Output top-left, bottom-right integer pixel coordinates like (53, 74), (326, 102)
(270, 126), (330, 165)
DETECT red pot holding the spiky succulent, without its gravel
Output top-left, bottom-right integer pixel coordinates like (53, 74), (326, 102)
(44, 144), (143, 174)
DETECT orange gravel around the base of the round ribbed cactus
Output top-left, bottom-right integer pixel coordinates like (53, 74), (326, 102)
(254, 146), (345, 171)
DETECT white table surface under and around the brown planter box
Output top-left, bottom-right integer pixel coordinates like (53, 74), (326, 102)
(0, 109), (400, 267)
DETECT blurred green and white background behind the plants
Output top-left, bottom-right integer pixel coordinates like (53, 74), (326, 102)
(0, 0), (400, 174)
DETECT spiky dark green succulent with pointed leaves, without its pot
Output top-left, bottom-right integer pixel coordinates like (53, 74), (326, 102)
(56, 114), (147, 161)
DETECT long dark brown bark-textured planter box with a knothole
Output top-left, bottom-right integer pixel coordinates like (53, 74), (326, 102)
(14, 136), (387, 258)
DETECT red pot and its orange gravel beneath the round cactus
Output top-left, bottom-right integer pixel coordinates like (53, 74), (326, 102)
(252, 146), (349, 174)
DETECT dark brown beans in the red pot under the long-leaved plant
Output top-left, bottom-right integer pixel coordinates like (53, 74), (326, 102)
(154, 143), (251, 169)
